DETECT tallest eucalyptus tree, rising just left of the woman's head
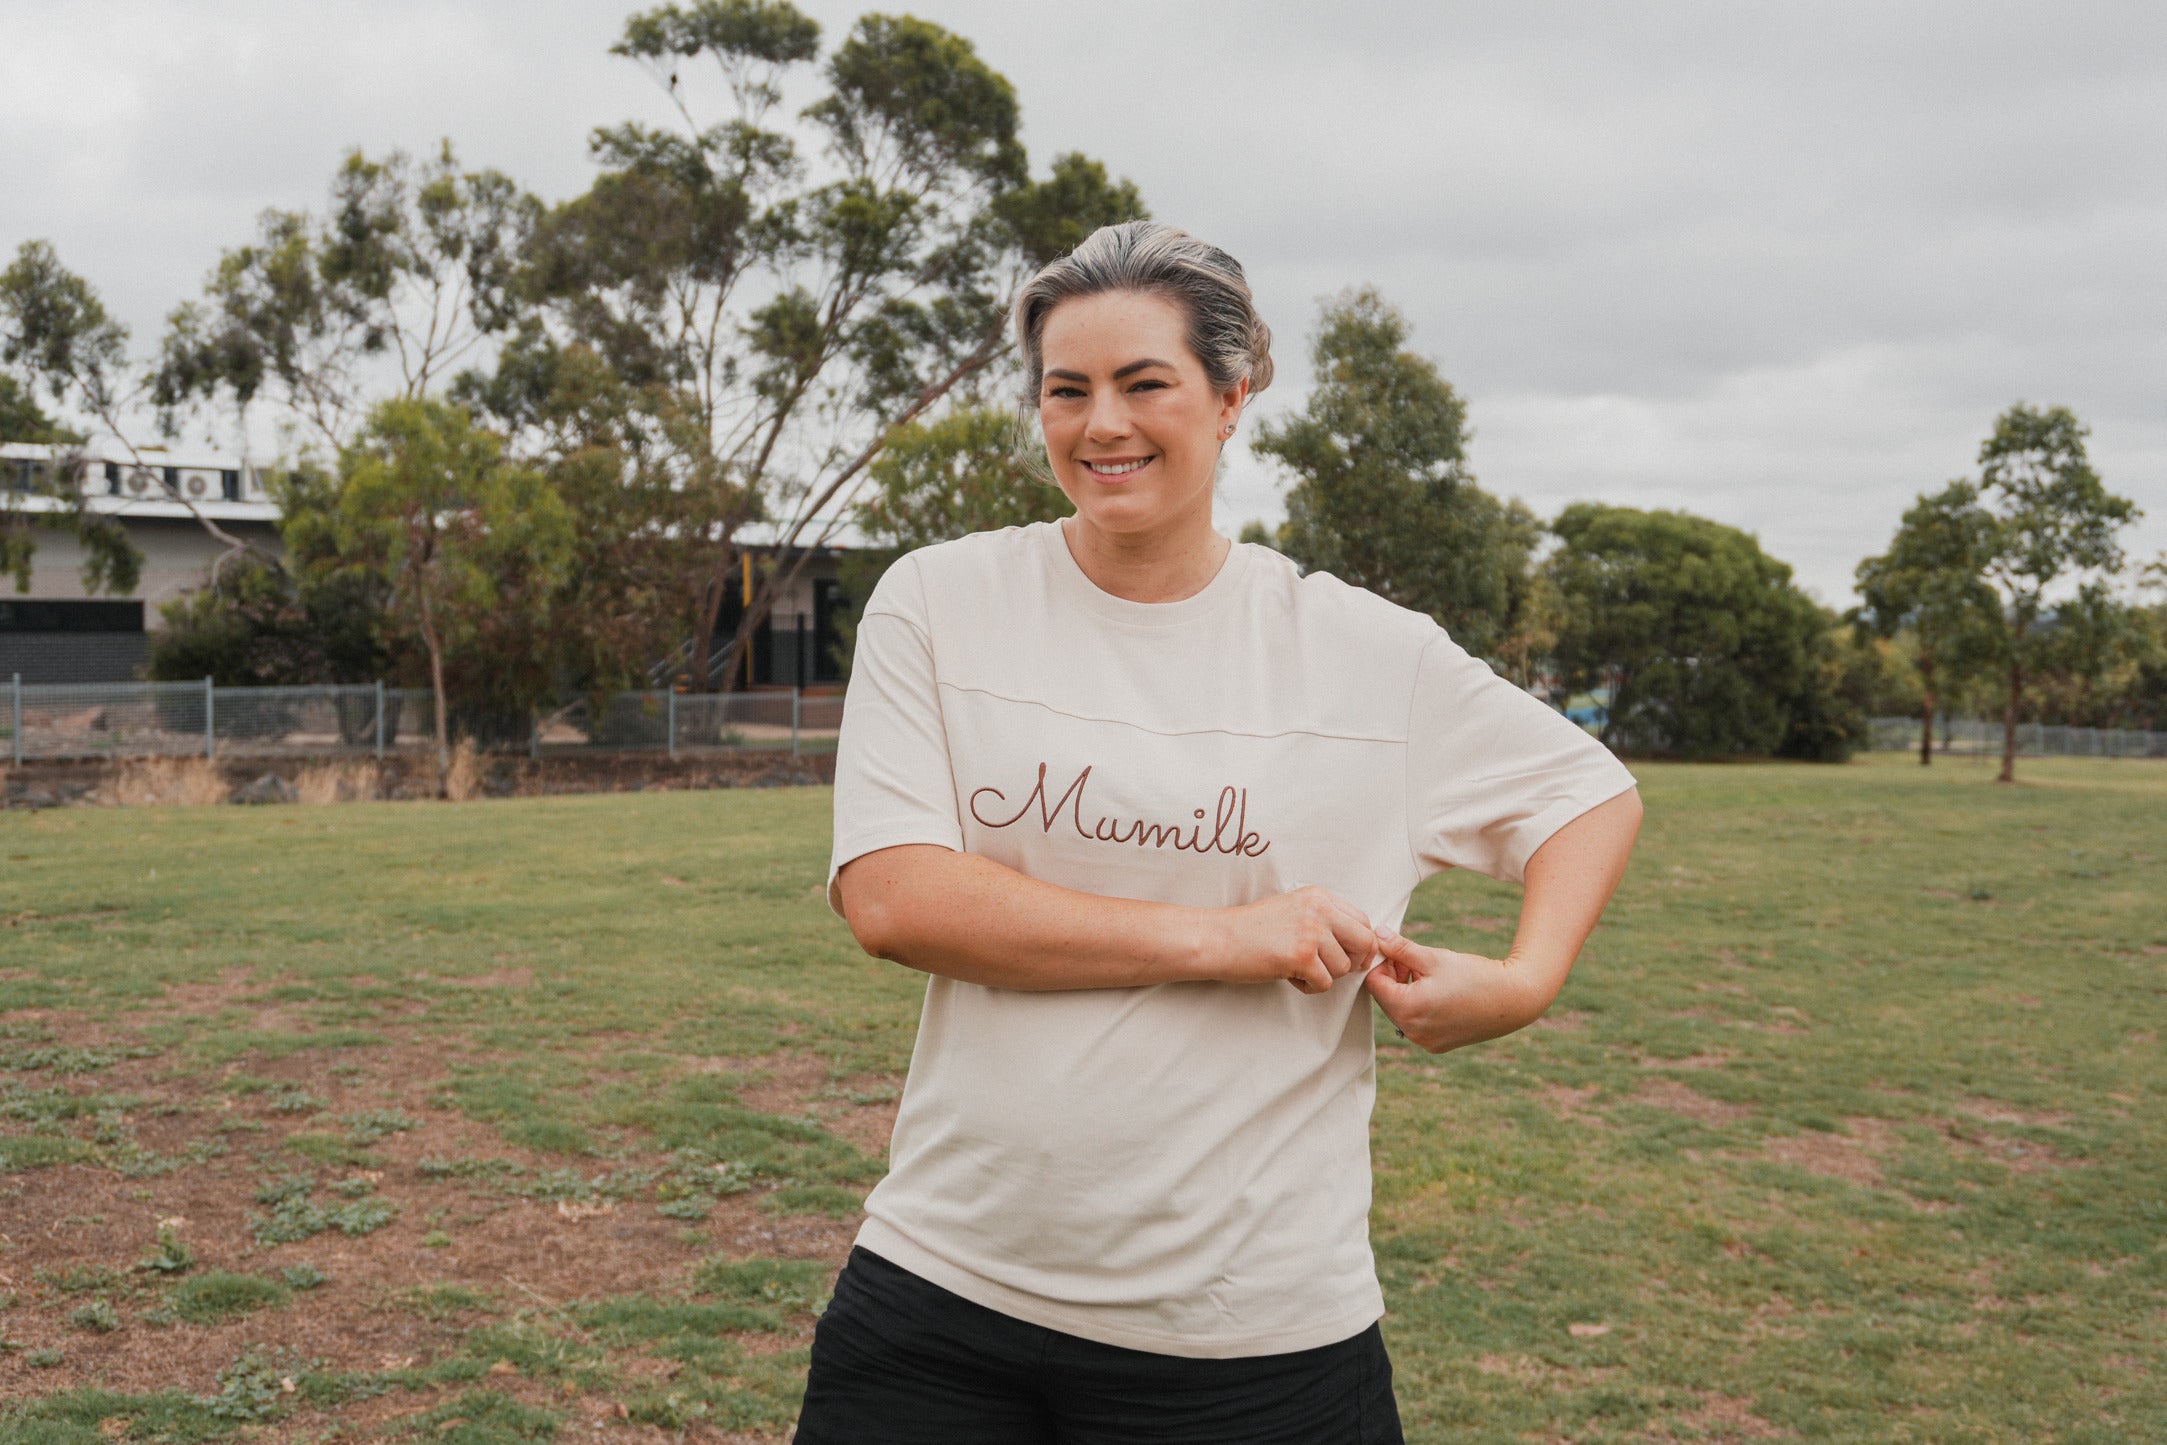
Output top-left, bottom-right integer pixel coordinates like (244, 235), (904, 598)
(507, 0), (1142, 680)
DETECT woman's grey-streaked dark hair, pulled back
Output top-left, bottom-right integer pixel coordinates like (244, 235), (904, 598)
(1016, 221), (1272, 409)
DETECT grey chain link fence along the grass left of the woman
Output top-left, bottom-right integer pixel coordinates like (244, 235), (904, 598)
(0, 678), (843, 763)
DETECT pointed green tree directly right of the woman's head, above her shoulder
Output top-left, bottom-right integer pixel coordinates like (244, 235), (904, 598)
(1253, 290), (1539, 674)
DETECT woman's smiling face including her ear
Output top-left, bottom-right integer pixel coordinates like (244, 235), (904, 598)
(1038, 290), (1248, 535)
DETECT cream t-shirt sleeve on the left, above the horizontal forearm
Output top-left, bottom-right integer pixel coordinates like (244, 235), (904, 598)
(828, 557), (962, 908)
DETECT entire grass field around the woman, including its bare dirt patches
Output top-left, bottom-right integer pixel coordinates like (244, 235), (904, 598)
(0, 758), (2167, 1445)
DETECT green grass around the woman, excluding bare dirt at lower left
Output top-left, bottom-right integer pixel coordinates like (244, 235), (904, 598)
(0, 756), (2167, 1445)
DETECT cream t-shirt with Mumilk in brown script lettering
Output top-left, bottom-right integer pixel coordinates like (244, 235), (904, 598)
(830, 522), (1634, 1358)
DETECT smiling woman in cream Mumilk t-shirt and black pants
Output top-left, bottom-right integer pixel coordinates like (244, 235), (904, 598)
(795, 221), (1640, 1445)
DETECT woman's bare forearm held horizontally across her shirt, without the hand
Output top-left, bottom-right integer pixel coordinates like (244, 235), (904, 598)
(836, 845), (1218, 990)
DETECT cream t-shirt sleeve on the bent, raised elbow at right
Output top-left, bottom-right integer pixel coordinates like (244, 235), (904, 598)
(1406, 633), (1634, 882)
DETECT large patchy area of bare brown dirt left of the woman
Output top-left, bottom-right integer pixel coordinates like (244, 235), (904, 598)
(0, 1005), (862, 1443)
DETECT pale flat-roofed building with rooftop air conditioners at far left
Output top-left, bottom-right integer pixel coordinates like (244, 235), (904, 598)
(0, 442), (280, 682)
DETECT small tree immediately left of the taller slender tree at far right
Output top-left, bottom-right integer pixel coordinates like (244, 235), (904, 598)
(1855, 481), (1996, 765)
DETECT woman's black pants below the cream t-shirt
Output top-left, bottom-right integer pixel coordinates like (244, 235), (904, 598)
(795, 1250), (1402, 1445)
